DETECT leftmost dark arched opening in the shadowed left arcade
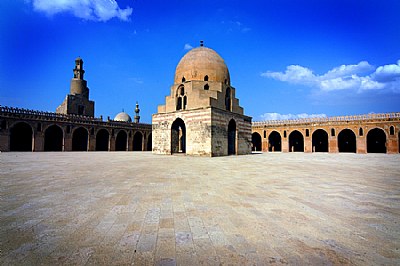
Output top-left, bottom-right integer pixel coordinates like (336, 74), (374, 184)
(10, 122), (33, 151)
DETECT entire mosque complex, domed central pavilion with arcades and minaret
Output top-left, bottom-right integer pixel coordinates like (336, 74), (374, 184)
(0, 43), (400, 156)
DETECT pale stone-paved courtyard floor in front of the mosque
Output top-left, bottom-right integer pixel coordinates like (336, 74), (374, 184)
(0, 152), (400, 265)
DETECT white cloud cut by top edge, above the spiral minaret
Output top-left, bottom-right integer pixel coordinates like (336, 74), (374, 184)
(32, 0), (132, 21)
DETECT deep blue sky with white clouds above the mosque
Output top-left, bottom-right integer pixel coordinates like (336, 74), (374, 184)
(0, 0), (400, 123)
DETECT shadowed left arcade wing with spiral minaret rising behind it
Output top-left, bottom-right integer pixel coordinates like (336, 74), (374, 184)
(0, 57), (152, 151)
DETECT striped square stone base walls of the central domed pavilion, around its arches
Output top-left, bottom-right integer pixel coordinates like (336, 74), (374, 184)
(152, 107), (251, 156)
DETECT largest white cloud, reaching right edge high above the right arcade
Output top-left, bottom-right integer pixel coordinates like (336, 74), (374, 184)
(261, 60), (400, 92)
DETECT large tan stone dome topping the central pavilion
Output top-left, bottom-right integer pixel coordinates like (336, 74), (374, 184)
(175, 46), (230, 85)
